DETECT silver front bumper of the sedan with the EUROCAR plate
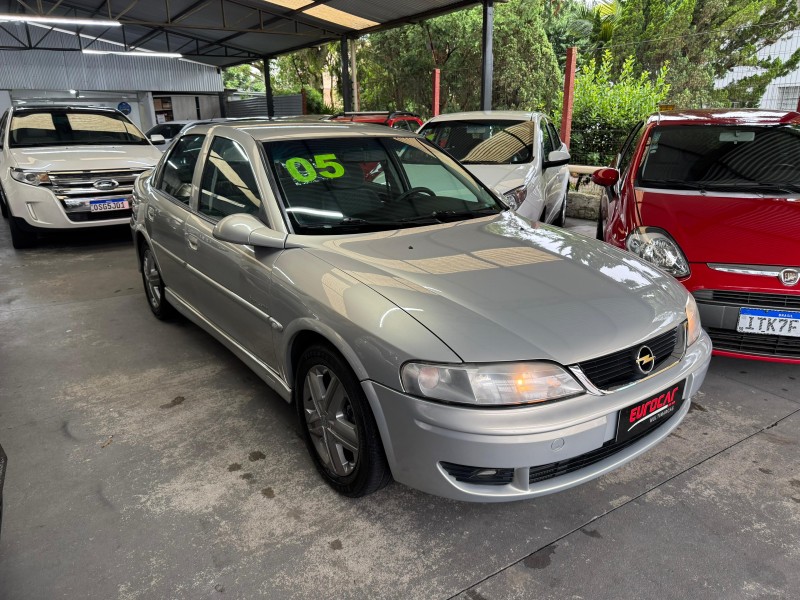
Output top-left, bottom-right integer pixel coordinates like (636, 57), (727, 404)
(362, 334), (711, 502)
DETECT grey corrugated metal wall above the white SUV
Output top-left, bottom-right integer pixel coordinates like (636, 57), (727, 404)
(0, 23), (223, 92)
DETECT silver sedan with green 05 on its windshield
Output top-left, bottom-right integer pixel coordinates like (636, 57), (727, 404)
(131, 122), (711, 502)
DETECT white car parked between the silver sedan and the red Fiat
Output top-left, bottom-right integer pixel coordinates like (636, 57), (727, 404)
(419, 110), (570, 226)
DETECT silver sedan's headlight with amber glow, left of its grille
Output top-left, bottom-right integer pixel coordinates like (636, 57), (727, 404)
(401, 362), (584, 406)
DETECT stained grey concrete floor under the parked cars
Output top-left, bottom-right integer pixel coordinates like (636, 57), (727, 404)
(0, 222), (800, 600)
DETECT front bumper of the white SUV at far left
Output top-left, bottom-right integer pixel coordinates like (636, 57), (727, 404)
(3, 177), (131, 229)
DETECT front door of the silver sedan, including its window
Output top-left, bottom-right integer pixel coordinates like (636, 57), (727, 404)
(186, 135), (281, 367)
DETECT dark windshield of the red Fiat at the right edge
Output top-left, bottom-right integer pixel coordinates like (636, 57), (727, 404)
(637, 125), (800, 192)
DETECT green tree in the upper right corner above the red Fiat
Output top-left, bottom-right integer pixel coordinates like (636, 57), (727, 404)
(608, 0), (800, 107)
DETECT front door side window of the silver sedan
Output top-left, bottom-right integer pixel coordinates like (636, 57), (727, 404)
(197, 137), (261, 219)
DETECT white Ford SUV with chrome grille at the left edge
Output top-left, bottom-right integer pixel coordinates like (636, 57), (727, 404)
(0, 105), (164, 248)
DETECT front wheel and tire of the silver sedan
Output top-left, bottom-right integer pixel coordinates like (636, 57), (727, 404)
(294, 345), (392, 498)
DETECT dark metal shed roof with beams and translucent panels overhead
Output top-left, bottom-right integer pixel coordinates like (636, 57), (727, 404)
(0, 0), (480, 66)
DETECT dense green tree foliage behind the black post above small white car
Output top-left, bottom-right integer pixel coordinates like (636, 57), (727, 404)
(358, 0), (561, 115)
